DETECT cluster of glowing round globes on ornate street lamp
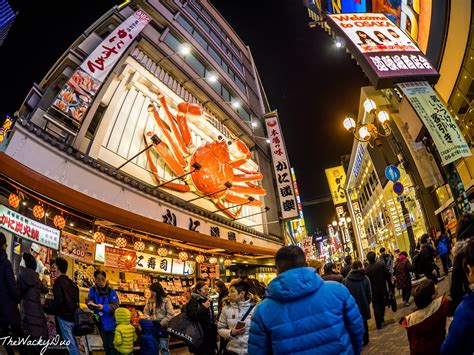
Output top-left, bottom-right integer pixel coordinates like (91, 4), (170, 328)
(342, 99), (392, 148)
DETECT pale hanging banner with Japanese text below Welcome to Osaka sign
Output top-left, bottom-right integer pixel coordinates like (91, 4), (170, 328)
(398, 82), (472, 165)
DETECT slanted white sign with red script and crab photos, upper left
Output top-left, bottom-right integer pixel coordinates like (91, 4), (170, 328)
(53, 10), (150, 122)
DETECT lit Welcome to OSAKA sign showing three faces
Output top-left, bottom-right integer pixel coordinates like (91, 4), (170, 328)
(327, 13), (439, 89)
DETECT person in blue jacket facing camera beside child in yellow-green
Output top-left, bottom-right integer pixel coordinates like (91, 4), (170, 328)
(87, 270), (120, 355)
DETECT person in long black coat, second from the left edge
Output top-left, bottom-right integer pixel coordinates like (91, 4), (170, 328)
(17, 253), (48, 339)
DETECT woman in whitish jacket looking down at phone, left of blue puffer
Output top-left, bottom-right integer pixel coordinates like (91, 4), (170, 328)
(217, 280), (255, 355)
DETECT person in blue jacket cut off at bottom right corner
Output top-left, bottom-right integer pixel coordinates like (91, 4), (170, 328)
(441, 239), (474, 355)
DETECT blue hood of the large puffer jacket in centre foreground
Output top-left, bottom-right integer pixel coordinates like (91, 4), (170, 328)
(266, 267), (324, 302)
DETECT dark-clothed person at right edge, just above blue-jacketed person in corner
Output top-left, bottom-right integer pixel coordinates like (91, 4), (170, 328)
(450, 213), (474, 306)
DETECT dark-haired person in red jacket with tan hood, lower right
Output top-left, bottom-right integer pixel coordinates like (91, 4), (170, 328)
(400, 280), (454, 355)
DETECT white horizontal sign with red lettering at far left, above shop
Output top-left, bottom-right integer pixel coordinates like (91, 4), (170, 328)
(0, 205), (60, 250)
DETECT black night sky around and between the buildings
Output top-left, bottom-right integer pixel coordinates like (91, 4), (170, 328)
(0, 0), (368, 232)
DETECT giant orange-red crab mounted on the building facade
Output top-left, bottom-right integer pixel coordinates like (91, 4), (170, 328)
(144, 94), (266, 218)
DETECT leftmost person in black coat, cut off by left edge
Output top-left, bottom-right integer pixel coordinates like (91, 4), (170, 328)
(0, 233), (23, 355)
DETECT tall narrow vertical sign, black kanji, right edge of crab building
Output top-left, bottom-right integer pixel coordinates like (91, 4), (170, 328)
(265, 116), (298, 219)
